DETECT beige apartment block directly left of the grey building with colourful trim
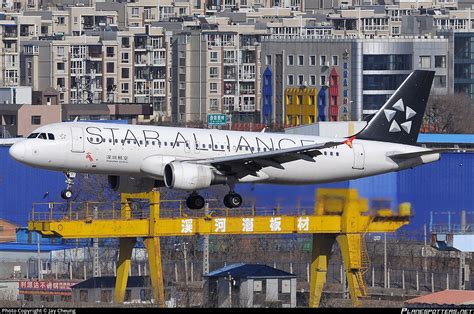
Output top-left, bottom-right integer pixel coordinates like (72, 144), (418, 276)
(172, 21), (266, 122)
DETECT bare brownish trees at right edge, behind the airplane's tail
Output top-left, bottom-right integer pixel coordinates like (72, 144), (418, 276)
(423, 93), (474, 133)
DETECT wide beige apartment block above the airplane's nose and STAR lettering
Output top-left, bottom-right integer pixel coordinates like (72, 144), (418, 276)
(21, 26), (170, 118)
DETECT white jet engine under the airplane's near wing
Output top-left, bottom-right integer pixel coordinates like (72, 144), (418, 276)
(164, 161), (227, 190)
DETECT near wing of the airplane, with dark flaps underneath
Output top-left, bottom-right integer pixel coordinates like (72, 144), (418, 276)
(181, 142), (345, 177)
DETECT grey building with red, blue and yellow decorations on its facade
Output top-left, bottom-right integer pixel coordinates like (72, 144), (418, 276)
(260, 36), (357, 125)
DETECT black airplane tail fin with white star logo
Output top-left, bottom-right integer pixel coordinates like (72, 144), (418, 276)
(355, 70), (435, 145)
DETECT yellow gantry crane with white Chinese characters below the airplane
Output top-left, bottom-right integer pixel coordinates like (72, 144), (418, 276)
(28, 189), (410, 307)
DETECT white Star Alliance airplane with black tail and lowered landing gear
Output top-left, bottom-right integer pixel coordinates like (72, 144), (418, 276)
(9, 70), (447, 209)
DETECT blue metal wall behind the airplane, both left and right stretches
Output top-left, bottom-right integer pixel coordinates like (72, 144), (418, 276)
(0, 147), (474, 228)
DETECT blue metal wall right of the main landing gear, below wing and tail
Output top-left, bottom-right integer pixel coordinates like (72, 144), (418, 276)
(237, 153), (474, 228)
